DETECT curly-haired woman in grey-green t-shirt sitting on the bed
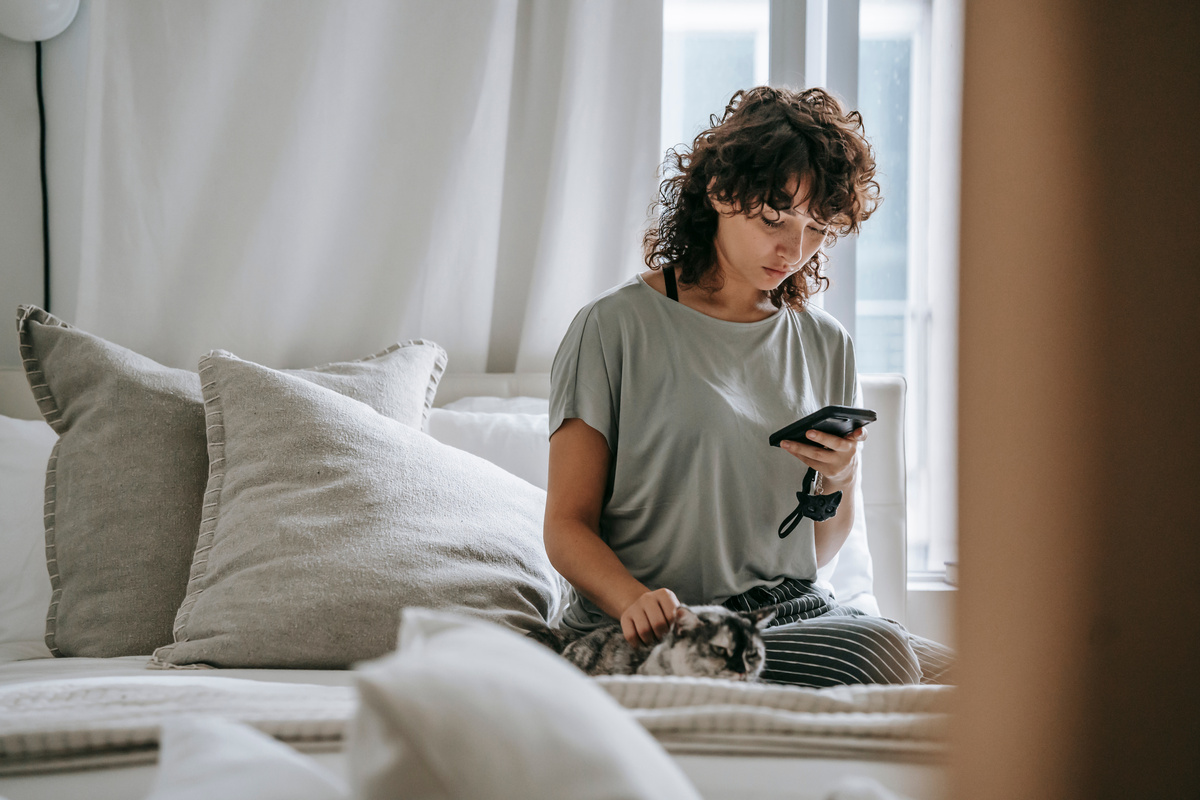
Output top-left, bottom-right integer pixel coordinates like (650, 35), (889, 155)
(545, 86), (949, 686)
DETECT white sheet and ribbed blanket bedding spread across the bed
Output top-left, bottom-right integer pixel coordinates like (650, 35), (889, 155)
(0, 657), (953, 800)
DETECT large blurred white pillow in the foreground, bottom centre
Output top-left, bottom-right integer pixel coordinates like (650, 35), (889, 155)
(347, 608), (700, 800)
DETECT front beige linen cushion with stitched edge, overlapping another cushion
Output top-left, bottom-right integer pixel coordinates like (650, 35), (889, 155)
(154, 351), (560, 669)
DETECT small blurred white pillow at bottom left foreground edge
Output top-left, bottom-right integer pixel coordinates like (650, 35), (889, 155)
(146, 716), (350, 800)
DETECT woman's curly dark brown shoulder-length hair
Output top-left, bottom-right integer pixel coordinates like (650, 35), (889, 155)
(643, 86), (881, 309)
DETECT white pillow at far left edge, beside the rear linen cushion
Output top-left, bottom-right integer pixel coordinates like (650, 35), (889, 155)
(0, 416), (58, 663)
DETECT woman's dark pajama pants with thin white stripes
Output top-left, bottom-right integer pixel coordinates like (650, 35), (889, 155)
(725, 578), (954, 687)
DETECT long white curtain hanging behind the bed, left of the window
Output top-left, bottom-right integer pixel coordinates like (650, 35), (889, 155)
(55, 0), (661, 372)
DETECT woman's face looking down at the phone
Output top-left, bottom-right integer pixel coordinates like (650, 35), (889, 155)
(712, 181), (826, 291)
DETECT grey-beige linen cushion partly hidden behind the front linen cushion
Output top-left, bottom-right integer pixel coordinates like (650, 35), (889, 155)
(17, 306), (446, 657)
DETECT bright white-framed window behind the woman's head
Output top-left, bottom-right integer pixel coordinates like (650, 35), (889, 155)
(662, 0), (961, 572)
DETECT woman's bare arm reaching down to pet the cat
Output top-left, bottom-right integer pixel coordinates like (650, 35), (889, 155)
(542, 419), (678, 644)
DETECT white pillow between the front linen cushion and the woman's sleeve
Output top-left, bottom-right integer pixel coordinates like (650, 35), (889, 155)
(426, 410), (550, 489)
